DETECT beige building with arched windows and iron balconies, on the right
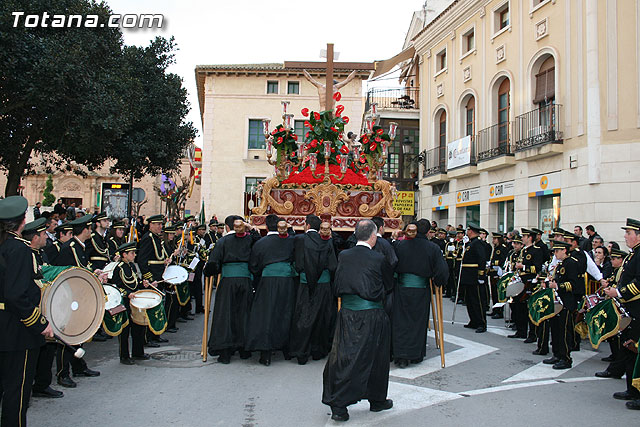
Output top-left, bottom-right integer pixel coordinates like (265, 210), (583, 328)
(403, 0), (640, 241)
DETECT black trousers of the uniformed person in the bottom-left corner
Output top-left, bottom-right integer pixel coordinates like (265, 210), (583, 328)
(0, 348), (40, 427)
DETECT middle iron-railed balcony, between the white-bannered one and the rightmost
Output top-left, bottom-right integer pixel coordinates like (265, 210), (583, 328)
(476, 121), (515, 171)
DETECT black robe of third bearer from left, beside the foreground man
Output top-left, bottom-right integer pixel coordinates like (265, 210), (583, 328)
(289, 231), (338, 359)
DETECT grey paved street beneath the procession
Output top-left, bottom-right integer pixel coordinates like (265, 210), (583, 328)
(28, 300), (638, 427)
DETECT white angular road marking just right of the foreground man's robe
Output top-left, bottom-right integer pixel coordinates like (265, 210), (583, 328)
(389, 331), (498, 380)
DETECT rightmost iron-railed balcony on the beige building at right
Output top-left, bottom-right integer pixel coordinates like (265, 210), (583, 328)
(514, 104), (563, 160)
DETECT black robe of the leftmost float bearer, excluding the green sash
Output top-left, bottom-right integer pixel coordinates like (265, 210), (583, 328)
(204, 233), (253, 355)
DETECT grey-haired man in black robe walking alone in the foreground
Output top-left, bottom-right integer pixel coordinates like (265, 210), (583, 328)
(322, 220), (393, 421)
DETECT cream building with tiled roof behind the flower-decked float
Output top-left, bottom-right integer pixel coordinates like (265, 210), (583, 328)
(195, 63), (370, 220)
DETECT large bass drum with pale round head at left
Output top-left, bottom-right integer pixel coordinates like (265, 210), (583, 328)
(40, 267), (106, 345)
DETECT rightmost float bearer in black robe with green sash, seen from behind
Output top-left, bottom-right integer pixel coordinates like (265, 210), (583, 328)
(391, 221), (449, 368)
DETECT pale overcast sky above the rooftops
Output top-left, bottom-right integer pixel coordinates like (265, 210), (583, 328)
(107, 0), (424, 146)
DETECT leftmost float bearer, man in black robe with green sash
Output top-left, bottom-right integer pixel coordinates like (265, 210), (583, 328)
(204, 215), (254, 364)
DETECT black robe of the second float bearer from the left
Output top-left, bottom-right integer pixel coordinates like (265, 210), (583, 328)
(245, 234), (295, 351)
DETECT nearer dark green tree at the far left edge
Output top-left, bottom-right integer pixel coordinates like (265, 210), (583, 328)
(0, 0), (130, 196)
